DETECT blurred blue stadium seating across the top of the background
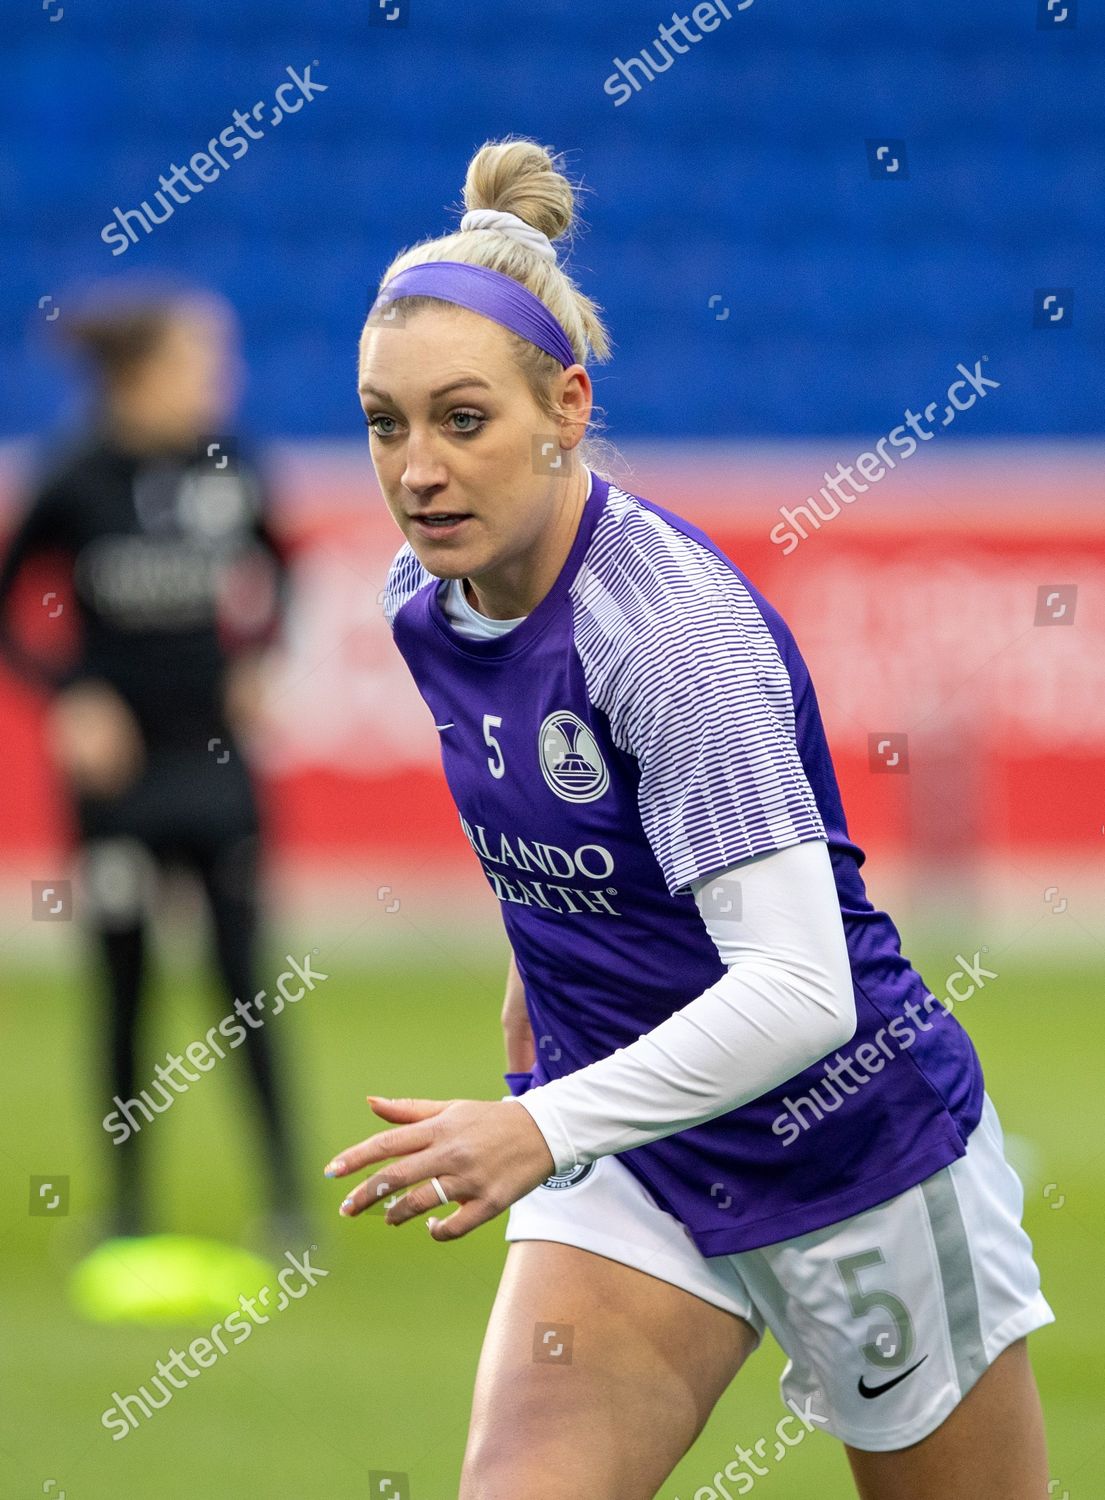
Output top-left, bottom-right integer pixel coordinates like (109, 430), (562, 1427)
(0, 0), (1105, 435)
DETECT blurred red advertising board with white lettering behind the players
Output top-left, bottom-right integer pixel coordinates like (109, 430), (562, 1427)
(0, 443), (1105, 866)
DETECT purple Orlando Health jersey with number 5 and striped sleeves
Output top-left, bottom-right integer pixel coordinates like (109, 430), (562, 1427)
(384, 474), (982, 1256)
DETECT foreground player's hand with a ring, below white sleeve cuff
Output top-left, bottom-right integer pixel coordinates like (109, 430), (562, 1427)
(325, 1094), (556, 1239)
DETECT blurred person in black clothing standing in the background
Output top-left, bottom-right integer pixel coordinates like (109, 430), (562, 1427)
(0, 284), (301, 1314)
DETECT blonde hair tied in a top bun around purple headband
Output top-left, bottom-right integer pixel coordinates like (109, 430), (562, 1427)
(370, 137), (610, 470)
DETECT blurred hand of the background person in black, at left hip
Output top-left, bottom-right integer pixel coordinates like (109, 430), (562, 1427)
(46, 681), (145, 797)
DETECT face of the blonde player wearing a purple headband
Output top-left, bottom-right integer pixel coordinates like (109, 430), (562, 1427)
(360, 308), (591, 612)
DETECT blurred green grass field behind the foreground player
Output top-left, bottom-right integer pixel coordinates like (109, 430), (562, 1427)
(0, 944), (1105, 1500)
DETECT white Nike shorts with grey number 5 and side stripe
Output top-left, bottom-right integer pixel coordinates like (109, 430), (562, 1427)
(507, 1095), (1054, 1452)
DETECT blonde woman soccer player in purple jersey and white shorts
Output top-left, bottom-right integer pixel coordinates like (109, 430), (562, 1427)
(325, 138), (1053, 1500)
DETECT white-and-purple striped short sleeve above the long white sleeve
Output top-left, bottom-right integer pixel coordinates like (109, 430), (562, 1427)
(576, 507), (826, 896)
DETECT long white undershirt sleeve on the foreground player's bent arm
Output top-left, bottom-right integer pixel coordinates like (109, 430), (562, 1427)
(514, 839), (856, 1172)
